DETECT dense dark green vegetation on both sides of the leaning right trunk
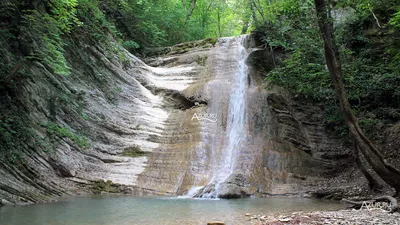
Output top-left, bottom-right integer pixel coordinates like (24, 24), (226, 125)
(256, 0), (400, 139)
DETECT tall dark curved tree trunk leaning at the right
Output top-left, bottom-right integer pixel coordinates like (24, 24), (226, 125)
(314, 0), (400, 192)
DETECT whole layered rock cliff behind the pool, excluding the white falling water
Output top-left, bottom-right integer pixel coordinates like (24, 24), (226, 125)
(0, 36), (360, 204)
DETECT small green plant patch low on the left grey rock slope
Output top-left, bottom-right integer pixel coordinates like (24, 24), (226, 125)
(41, 123), (90, 148)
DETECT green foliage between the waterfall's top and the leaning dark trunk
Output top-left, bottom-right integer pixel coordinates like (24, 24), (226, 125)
(257, 1), (334, 101)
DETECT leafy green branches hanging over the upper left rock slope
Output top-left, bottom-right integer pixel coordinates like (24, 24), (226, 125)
(20, 0), (81, 75)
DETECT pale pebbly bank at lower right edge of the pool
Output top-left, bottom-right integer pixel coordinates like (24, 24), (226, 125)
(247, 209), (400, 225)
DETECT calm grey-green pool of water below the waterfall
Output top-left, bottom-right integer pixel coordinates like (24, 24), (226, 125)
(0, 196), (343, 225)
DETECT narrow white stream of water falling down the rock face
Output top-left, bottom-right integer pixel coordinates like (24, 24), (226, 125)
(189, 35), (249, 198)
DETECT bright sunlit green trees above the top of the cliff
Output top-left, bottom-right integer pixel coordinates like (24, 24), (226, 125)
(99, 0), (244, 48)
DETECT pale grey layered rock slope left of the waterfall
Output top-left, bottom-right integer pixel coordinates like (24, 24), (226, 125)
(0, 37), (216, 204)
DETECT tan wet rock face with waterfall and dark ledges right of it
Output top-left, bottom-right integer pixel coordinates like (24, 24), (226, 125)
(139, 36), (358, 198)
